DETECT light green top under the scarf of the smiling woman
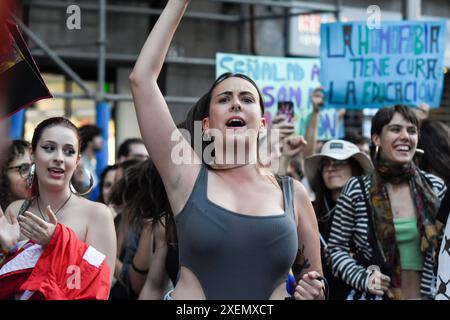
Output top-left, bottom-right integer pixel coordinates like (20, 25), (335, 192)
(394, 218), (423, 271)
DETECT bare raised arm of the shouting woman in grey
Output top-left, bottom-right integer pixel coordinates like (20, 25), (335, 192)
(126, 0), (199, 212)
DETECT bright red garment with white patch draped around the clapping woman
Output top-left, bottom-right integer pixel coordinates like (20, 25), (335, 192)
(0, 223), (110, 300)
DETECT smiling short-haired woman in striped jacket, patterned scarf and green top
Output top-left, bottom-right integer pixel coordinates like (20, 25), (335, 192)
(328, 105), (446, 299)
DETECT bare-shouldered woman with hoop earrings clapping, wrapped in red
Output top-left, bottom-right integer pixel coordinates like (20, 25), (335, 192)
(0, 117), (116, 299)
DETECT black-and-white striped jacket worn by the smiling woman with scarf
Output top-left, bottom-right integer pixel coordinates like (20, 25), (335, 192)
(328, 171), (446, 298)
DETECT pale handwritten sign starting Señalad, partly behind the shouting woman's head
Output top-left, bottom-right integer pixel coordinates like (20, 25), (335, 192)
(216, 53), (342, 140)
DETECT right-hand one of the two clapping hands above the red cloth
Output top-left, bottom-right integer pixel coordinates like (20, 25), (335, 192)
(18, 206), (58, 247)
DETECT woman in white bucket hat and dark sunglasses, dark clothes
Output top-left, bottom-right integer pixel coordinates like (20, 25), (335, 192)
(305, 140), (373, 300)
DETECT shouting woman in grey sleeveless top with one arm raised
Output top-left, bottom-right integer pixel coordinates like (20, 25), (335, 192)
(130, 0), (324, 299)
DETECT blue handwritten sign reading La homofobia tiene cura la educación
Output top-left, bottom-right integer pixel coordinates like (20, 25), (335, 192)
(320, 20), (446, 109)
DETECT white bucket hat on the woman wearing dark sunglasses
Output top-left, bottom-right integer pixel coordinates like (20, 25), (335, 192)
(305, 140), (373, 185)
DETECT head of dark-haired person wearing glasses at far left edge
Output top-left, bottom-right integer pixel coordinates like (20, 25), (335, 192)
(0, 140), (31, 209)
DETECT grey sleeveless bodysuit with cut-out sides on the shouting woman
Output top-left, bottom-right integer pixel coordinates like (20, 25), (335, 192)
(175, 165), (298, 300)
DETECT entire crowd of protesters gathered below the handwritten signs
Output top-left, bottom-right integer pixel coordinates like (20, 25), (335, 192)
(0, 0), (450, 300)
